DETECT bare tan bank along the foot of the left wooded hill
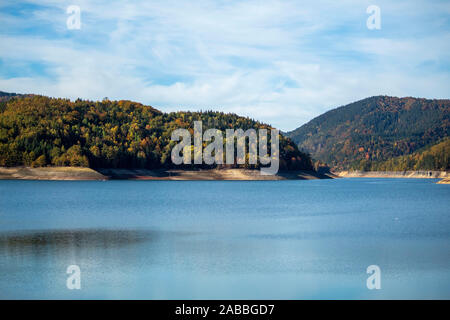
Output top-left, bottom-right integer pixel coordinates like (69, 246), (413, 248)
(0, 167), (335, 181)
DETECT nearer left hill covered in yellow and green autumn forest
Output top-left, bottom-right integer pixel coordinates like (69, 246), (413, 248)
(0, 96), (312, 170)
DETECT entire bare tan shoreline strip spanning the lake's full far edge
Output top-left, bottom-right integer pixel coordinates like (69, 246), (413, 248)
(0, 167), (450, 184)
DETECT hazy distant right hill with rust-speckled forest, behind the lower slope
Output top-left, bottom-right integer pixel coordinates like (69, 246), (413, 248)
(286, 96), (450, 170)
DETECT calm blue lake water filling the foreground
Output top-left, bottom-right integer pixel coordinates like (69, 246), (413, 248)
(0, 179), (450, 299)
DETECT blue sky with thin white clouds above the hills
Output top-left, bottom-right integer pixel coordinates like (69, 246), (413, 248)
(0, 0), (450, 130)
